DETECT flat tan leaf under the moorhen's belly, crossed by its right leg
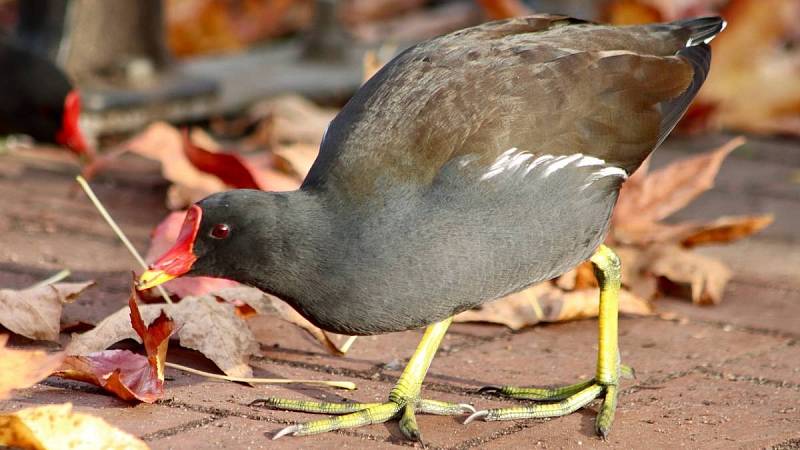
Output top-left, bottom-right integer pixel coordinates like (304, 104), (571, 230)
(454, 283), (653, 330)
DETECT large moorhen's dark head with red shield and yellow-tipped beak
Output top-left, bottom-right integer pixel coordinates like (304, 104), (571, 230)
(138, 189), (270, 289)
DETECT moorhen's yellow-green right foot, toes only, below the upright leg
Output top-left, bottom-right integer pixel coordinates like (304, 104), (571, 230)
(464, 365), (634, 438)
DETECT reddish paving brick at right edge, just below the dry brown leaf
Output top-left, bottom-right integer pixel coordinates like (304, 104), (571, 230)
(658, 279), (800, 336)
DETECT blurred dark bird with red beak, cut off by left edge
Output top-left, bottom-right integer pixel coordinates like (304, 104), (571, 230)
(0, 39), (91, 155)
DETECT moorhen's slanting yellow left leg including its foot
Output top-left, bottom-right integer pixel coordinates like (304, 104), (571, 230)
(254, 318), (475, 440)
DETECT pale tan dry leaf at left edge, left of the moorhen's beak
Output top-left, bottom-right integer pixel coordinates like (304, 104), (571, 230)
(0, 281), (94, 341)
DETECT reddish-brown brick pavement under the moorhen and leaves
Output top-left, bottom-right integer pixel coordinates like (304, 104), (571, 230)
(0, 138), (800, 450)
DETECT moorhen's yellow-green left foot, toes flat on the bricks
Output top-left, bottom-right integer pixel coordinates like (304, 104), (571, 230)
(251, 398), (475, 441)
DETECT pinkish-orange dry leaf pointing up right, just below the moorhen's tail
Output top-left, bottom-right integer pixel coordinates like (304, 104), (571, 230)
(613, 137), (745, 228)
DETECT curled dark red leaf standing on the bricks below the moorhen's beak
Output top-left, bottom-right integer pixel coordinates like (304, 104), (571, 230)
(54, 289), (175, 403)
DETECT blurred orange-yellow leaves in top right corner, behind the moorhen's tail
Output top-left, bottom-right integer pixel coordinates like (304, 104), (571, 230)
(698, 0), (800, 135)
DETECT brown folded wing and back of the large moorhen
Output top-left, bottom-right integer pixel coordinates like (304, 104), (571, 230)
(304, 16), (702, 198)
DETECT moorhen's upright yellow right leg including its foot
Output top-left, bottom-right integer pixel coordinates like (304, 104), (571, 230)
(465, 245), (633, 437)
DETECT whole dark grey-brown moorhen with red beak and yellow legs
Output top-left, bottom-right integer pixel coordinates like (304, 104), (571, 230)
(137, 14), (725, 440)
